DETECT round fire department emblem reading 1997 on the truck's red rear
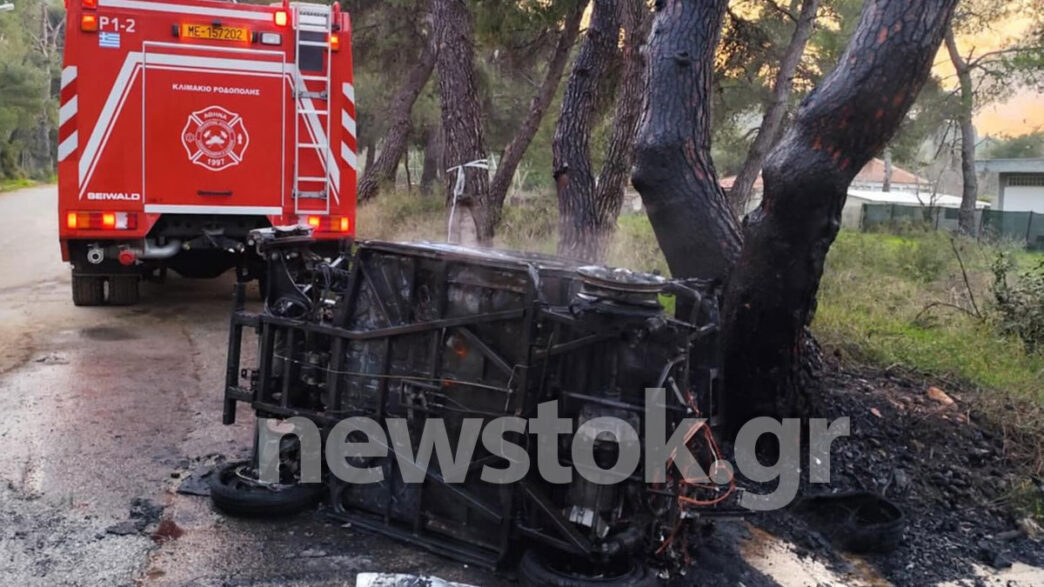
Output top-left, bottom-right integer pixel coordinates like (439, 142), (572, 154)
(182, 105), (251, 171)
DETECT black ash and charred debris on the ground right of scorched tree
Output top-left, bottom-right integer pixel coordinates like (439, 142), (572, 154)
(750, 368), (1044, 585)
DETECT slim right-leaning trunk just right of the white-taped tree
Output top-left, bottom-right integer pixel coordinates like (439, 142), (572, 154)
(490, 0), (587, 212)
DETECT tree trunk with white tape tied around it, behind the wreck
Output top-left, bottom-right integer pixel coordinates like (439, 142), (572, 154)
(431, 0), (496, 245)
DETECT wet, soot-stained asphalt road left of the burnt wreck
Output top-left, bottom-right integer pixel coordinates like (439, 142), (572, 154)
(0, 186), (503, 585)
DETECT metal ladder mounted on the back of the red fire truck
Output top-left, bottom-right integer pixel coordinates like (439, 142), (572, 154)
(293, 3), (336, 214)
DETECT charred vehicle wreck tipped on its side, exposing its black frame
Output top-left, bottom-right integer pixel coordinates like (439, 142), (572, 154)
(214, 229), (734, 585)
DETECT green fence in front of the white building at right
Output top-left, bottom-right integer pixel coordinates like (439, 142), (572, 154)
(859, 204), (1044, 251)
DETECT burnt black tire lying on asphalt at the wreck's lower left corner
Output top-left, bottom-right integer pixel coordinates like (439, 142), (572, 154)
(210, 462), (325, 518)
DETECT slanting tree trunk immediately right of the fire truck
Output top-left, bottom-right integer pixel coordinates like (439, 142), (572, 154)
(358, 46), (435, 202)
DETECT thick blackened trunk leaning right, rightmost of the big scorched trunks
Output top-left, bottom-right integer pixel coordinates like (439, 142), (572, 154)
(722, 0), (956, 430)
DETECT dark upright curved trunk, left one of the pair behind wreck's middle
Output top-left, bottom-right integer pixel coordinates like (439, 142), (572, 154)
(551, 0), (620, 256)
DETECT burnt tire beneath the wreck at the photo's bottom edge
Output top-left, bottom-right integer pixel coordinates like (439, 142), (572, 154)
(519, 549), (660, 587)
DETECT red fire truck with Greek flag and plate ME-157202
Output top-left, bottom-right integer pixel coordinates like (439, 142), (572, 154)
(57, 0), (357, 305)
